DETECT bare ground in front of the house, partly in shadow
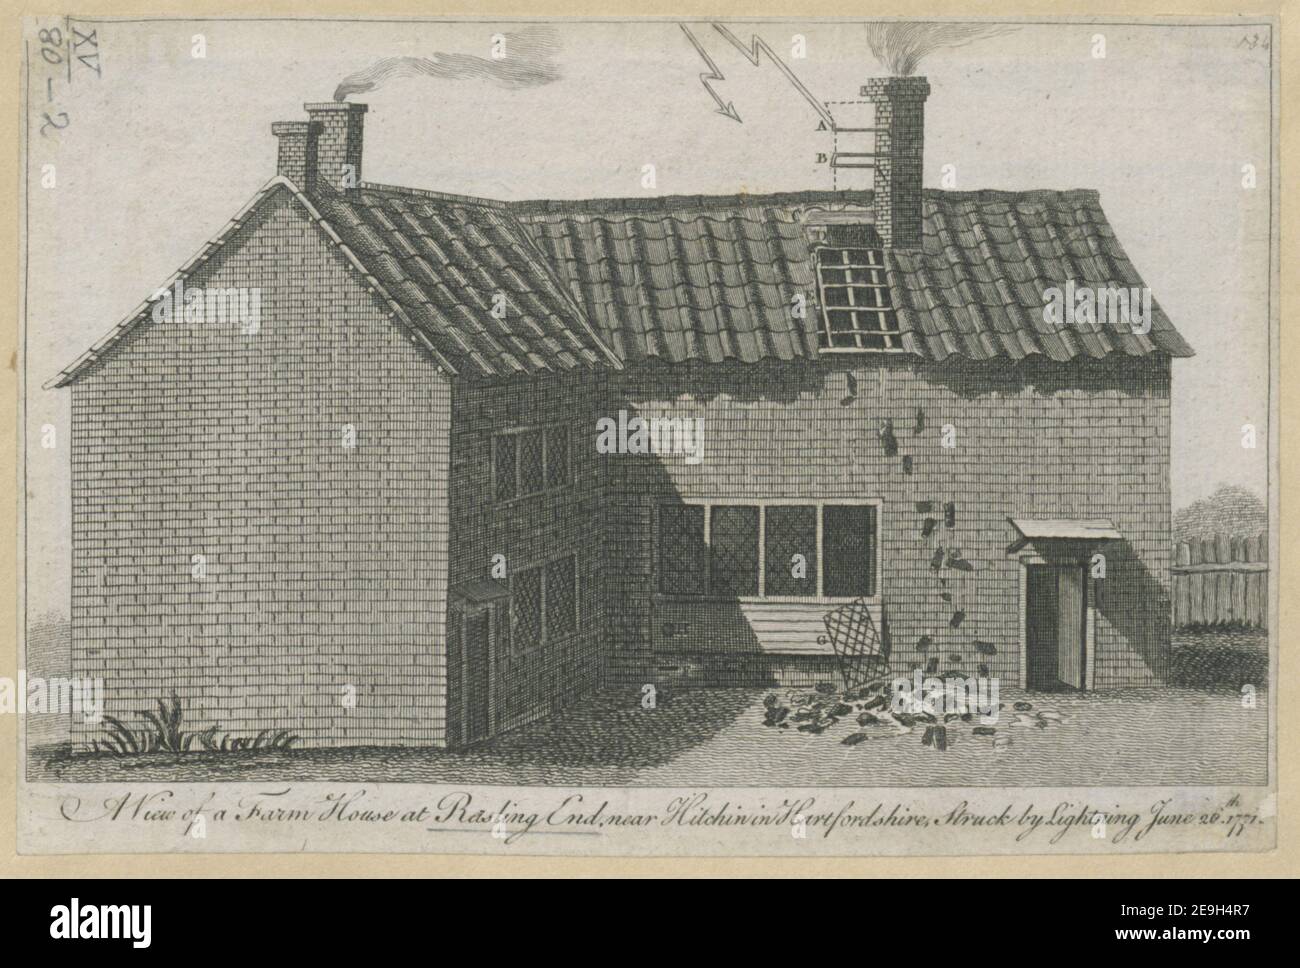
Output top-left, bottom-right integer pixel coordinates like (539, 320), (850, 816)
(27, 630), (1269, 787)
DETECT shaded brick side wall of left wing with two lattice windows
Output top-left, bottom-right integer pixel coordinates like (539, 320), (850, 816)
(449, 372), (607, 733)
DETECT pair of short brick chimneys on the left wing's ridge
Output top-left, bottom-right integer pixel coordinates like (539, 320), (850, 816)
(270, 101), (367, 195)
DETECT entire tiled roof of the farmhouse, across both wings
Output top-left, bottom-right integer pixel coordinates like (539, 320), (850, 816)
(48, 177), (1192, 386)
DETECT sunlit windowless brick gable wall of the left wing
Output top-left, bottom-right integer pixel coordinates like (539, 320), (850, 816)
(72, 192), (451, 746)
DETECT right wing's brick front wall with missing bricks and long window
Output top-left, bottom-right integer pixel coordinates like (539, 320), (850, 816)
(608, 356), (1170, 689)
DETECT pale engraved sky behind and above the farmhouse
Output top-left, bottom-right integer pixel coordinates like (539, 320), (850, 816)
(25, 19), (1273, 613)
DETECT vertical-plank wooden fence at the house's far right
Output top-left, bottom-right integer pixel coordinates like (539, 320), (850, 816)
(1173, 534), (1269, 629)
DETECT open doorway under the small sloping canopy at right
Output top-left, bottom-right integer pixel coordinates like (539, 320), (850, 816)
(1024, 564), (1088, 690)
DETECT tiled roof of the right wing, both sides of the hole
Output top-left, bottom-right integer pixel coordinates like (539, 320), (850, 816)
(511, 191), (1192, 363)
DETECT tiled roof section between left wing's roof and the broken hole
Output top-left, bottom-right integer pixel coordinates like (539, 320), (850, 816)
(512, 194), (835, 363)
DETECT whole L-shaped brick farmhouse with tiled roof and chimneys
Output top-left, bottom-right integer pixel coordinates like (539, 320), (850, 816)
(51, 77), (1191, 746)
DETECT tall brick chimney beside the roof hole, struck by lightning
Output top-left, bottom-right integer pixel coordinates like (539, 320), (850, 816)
(862, 77), (930, 248)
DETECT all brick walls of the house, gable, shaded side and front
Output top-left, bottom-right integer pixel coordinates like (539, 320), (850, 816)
(61, 174), (1170, 745)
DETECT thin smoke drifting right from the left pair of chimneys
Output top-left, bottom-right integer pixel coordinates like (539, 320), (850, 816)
(334, 26), (562, 101)
